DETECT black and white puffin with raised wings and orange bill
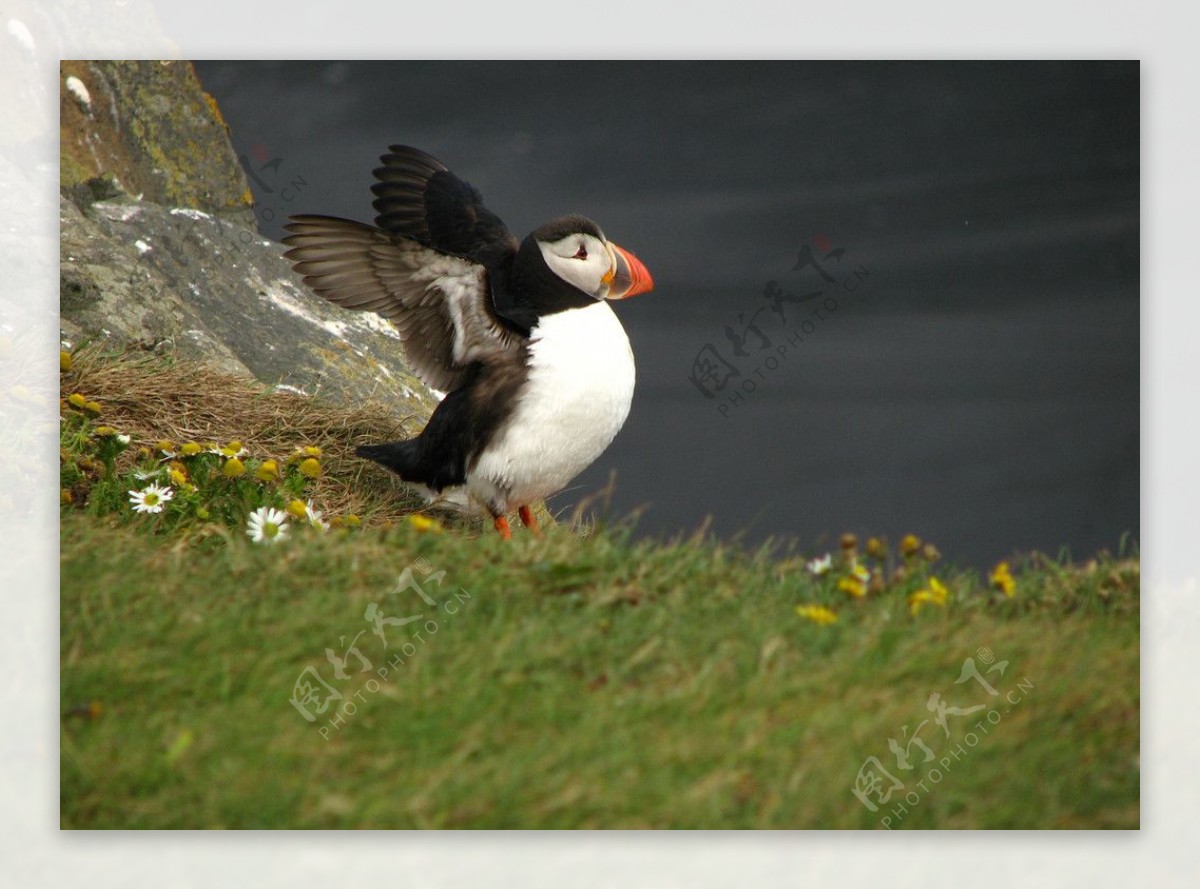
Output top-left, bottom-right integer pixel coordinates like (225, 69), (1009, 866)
(283, 145), (654, 539)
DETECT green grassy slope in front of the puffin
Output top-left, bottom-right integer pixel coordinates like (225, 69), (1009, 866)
(61, 511), (1139, 828)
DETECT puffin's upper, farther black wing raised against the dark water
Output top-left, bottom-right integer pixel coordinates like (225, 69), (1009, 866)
(371, 145), (517, 269)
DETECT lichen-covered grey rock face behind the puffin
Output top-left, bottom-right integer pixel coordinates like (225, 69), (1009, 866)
(59, 61), (436, 415)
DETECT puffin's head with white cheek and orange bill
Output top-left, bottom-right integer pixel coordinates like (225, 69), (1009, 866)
(514, 216), (654, 315)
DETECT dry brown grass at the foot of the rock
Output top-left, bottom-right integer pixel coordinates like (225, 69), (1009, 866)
(60, 349), (456, 523)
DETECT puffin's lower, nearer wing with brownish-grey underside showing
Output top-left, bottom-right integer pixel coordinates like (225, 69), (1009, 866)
(283, 215), (521, 392)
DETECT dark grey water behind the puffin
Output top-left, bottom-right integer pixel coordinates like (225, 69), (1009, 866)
(197, 62), (1140, 564)
